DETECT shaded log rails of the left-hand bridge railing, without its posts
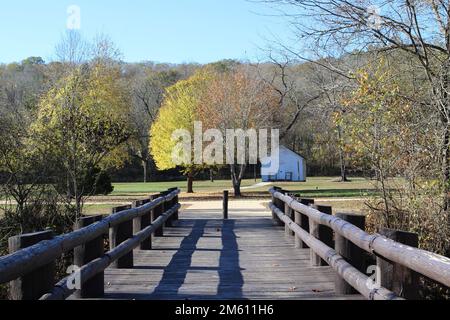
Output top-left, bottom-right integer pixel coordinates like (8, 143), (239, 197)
(0, 189), (180, 298)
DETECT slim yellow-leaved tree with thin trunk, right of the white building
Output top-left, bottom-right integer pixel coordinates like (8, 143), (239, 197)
(335, 62), (412, 216)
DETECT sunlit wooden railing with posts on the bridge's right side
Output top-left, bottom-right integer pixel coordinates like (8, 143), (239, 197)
(270, 188), (450, 300)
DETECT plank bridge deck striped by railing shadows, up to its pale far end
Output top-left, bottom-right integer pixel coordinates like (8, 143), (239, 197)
(94, 200), (361, 300)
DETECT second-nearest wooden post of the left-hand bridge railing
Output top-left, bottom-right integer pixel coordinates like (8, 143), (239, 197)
(73, 216), (105, 299)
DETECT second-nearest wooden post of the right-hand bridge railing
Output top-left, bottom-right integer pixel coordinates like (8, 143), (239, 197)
(334, 213), (366, 294)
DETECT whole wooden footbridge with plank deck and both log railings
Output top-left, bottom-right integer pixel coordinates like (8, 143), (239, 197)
(0, 189), (450, 300)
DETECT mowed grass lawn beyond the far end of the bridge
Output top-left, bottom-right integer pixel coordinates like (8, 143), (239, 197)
(0, 177), (384, 215)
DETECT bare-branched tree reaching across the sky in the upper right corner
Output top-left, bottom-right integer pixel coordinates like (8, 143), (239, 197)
(265, 0), (450, 210)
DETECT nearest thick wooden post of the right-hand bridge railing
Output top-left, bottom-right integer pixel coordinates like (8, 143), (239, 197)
(377, 229), (420, 300)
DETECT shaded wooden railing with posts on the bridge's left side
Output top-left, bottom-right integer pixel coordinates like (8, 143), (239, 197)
(0, 188), (180, 300)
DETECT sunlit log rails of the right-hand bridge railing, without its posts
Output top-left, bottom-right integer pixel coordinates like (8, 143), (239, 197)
(269, 188), (450, 298)
